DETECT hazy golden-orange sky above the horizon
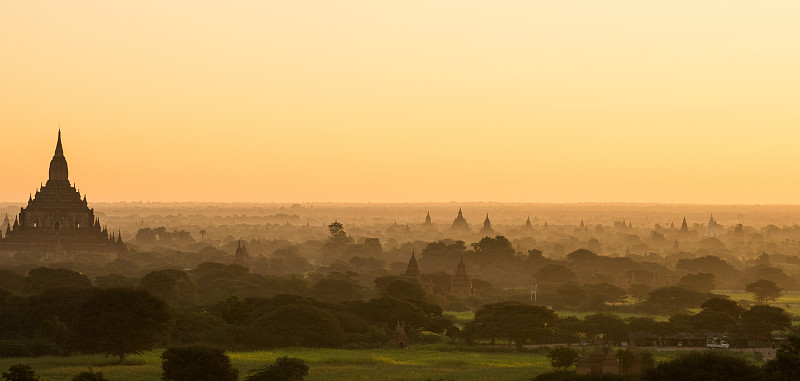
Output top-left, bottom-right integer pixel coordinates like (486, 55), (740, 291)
(0, 0), (800, 204)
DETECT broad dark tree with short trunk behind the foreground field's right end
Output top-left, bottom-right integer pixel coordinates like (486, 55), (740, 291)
(467, 302), (558, 349)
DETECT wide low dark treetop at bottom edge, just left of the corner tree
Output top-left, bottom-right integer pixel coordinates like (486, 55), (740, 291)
(641, 351), (762, 381)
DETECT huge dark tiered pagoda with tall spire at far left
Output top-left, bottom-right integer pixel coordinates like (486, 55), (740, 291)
(0, 130), (128, 262)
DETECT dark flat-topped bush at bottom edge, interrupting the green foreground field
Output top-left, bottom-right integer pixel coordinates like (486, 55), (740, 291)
(161, 345), (239, 381)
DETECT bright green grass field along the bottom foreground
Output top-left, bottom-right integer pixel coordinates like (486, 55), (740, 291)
(0, 347), (551, 381)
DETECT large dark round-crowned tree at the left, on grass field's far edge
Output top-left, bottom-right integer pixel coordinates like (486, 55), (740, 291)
(75, 288), (172, 364)
